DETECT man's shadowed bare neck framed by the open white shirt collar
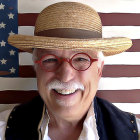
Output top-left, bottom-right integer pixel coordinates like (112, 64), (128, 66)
(48, 110), (85, 140)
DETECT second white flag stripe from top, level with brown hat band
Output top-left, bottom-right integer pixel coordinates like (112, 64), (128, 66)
(18, 26), (140, 39)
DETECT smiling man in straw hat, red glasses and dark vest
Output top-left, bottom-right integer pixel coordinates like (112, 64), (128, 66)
(1, 2), (140, 140)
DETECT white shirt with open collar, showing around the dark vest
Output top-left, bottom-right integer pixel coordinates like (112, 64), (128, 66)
(0, 106), (140, 140)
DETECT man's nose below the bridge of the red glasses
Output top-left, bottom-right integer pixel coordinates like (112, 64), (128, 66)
(56, 61), (76, 82)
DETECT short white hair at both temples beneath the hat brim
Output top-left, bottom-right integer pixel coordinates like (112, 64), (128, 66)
(32, 49), (104, 71)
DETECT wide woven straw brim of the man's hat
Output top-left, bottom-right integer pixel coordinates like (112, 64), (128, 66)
(8, 35), (132, 56)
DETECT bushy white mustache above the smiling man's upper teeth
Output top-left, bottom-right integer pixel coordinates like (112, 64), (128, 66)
(48, 80), (84, 90)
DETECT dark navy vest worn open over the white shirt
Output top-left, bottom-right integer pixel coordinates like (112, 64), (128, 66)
(5, 96), (138, 140)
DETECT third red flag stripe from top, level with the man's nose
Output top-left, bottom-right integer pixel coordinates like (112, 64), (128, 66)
(19, 65), (140, 78)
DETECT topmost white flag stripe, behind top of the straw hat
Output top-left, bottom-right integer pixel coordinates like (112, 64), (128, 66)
(18, 0), (140, 13)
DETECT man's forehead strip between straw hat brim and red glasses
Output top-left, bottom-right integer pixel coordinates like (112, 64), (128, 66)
(34, 49), (98, 58)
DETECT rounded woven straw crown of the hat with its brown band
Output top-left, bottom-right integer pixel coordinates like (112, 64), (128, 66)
(35, 2), (102, 38)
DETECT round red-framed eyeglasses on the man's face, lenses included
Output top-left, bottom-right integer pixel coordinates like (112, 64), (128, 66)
(35, 53), (98, 72)
